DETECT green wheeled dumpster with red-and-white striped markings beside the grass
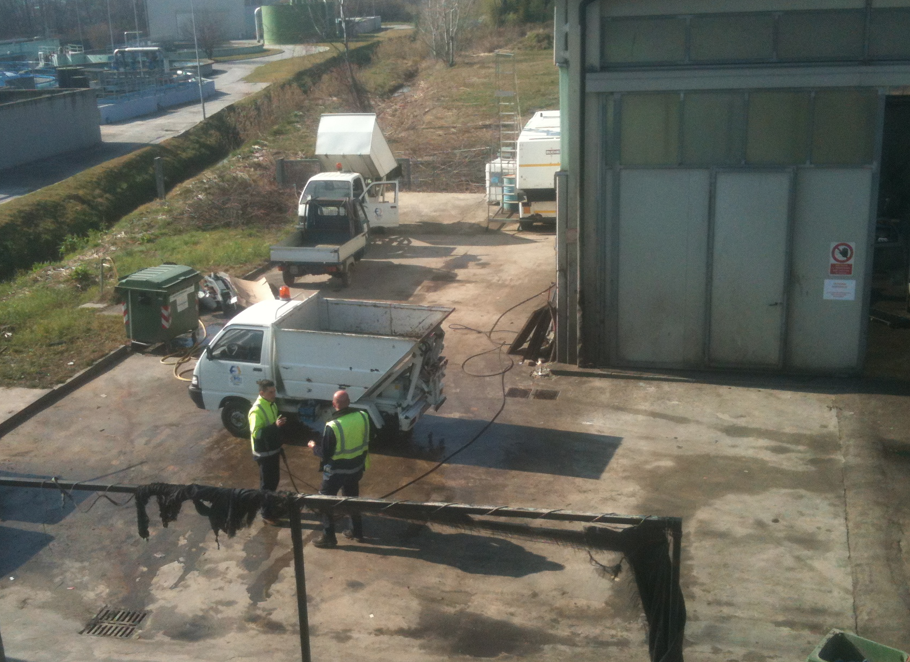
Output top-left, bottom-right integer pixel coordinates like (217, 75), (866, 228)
(115, 264), (201, 345)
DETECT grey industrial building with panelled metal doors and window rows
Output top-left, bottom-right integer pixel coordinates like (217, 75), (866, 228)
(555, 0), (910, 374)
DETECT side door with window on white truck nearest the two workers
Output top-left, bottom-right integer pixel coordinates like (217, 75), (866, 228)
(200, 327), (272, 403)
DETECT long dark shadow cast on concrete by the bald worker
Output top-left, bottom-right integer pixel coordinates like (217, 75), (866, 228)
(331, 517), (565, 578)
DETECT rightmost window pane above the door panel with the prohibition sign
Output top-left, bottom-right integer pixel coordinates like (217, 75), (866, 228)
(812, 90), (878, 165)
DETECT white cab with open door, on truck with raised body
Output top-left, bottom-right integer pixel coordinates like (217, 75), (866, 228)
(297, 172), (398, 230)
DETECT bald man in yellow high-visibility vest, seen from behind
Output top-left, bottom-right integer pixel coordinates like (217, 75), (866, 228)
(309, 391), (371, 548)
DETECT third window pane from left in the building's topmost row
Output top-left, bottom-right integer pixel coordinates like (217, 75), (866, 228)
(777, 11), (865, 60)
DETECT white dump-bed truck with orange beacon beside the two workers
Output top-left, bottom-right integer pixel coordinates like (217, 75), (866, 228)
(189, 294), (453, 437)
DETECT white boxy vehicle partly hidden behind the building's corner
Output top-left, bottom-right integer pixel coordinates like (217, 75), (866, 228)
(516, 110), (560, 227)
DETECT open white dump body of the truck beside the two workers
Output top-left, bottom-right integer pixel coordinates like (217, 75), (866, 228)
(274, 297), (452, 402)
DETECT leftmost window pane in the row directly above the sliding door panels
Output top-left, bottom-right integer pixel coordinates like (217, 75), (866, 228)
(620, 93), (679, 165)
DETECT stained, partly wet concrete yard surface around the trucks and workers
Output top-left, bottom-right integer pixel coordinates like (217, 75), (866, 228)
(0, 194), (910, 662)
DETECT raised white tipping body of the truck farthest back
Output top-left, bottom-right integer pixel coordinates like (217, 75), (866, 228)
(316, 113), (398, 180)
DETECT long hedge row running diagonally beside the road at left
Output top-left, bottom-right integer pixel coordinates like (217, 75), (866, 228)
(0, 41), (379, 279)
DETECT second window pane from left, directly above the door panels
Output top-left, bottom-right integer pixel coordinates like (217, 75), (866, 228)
(682, 92), (746, 165)
